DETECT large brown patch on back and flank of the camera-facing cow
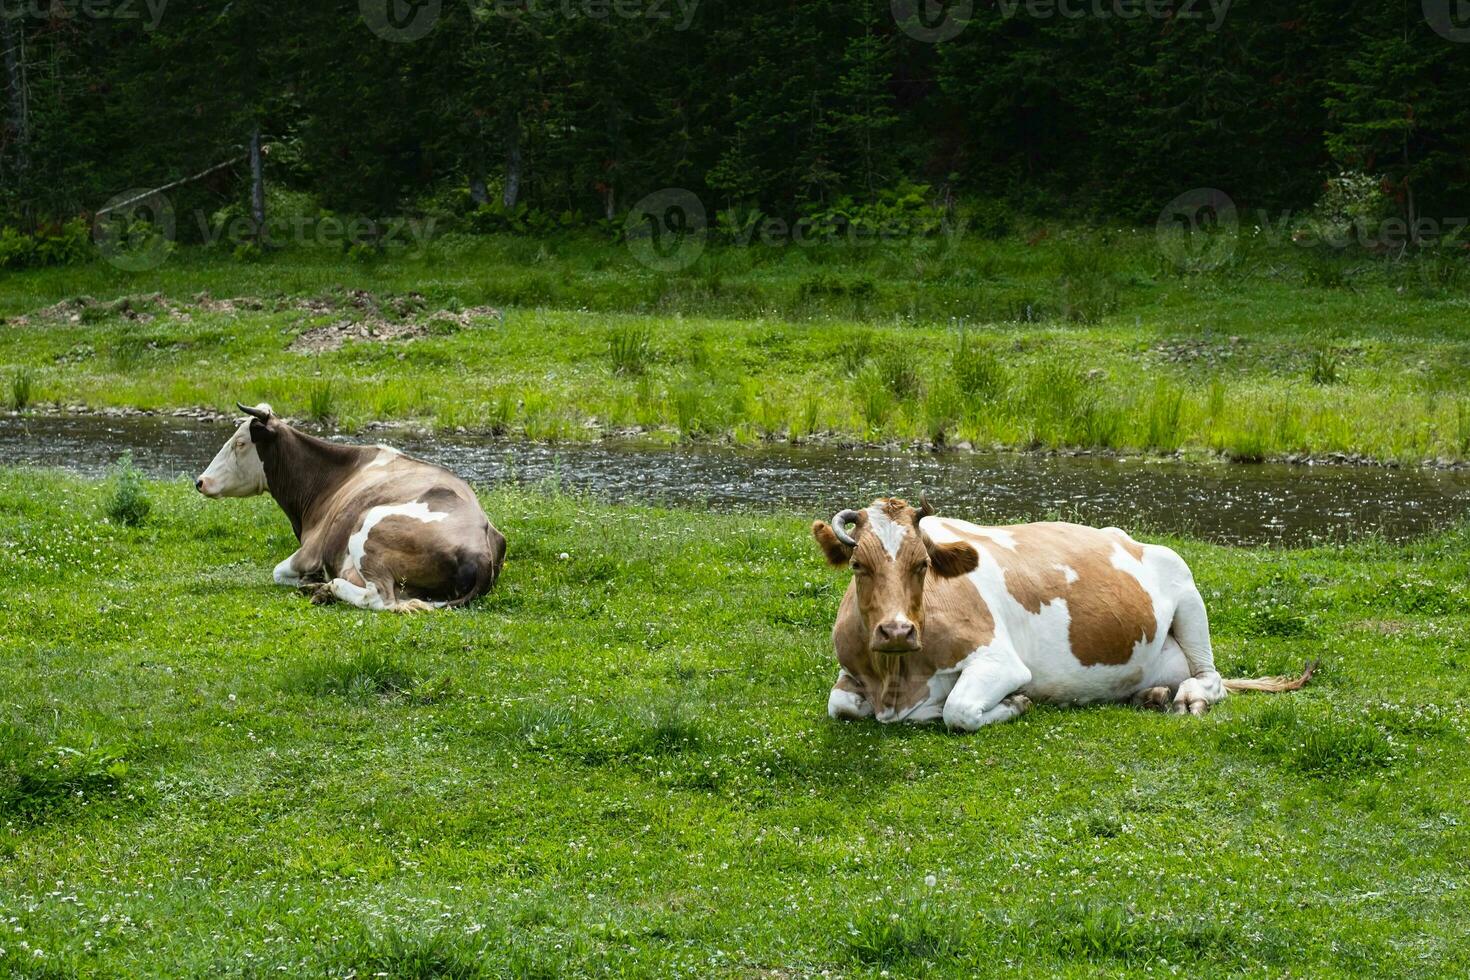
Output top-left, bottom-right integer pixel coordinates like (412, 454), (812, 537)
(945, 523), (1158, 667)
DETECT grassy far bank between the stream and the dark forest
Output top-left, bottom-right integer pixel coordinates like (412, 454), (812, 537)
(0, 238), (1470, 461)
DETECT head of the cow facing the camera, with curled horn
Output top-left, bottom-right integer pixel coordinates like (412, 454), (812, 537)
(811, 498), (980, 654)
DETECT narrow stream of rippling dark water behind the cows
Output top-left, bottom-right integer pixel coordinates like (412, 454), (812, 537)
(0, 416), (1470, 544)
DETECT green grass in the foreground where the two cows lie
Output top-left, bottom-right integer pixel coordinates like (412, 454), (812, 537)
(0, 470), (1470, 977)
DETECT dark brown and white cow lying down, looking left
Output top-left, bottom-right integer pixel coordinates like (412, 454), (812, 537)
(194, 404), (506, 613)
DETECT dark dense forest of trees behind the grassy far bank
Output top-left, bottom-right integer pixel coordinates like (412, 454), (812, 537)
(0, 0), (1470, 249)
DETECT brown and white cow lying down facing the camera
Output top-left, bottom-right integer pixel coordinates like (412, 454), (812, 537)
(811, 498), (1311, 730)
